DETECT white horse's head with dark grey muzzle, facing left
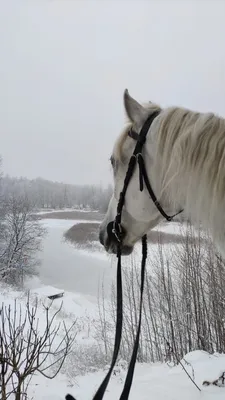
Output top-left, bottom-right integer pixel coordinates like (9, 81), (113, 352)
(99, 90), (178, 255)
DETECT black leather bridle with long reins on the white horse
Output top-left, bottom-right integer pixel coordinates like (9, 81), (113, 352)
(66, 111), (183, 400)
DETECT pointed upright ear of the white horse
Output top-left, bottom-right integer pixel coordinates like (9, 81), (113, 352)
(123, 89), (146, 125)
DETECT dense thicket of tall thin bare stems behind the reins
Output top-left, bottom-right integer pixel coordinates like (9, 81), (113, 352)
(96, 223), (225, 364)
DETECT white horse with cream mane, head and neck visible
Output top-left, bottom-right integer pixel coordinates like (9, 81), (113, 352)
(99, 90), (225, 257)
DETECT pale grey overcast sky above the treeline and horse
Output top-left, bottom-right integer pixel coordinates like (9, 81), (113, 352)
(0, 0), (225, 184)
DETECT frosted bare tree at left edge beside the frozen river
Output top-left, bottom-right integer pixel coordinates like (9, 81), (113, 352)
(0, 194), (46, 285)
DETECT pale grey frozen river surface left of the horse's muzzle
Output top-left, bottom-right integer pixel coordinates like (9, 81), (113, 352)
(36, 219), (116, 296)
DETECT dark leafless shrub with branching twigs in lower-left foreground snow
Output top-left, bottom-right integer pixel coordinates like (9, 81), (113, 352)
(0, 295), (76, 400)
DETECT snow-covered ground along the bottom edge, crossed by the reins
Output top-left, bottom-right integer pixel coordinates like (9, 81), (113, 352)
(33, 351), (225, 400)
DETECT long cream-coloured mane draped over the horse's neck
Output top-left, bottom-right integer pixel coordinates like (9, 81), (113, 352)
(155, 107), (225, 236)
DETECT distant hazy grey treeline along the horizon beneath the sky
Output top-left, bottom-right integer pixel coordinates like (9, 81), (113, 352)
(1, 175), (112, 212)
